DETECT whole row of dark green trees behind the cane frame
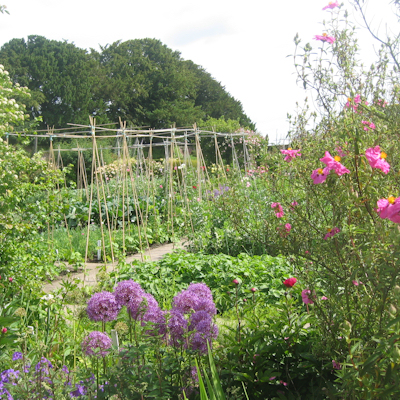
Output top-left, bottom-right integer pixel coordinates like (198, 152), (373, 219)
(0, 36), (255, 129)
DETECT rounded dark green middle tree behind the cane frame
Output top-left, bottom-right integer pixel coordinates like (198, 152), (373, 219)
(98, 39), (203, 128)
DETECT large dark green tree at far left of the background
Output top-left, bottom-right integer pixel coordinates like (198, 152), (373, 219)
(0, 36), (105, 127)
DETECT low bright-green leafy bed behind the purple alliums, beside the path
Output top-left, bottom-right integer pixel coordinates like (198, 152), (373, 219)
(112, 251), (292, 313)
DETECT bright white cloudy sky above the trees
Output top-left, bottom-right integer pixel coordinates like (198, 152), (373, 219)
(0, 0), (391, 142)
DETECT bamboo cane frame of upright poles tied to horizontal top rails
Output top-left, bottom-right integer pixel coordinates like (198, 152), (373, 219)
(6, 118), (251, 278)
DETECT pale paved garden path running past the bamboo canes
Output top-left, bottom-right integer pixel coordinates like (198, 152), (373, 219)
(43, 241), (184, 293)
